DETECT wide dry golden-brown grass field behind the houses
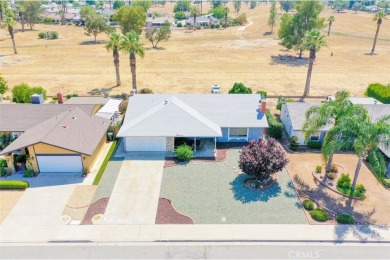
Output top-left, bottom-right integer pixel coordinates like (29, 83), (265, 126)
(0, 4), (390, 95)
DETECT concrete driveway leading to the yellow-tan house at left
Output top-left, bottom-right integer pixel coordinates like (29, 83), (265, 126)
(2, 173), (83, 226)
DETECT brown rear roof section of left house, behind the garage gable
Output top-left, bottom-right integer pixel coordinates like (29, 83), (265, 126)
(0, 104), (94, 132)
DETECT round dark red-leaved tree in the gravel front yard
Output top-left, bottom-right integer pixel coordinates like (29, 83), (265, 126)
(239, 138), (288, 180)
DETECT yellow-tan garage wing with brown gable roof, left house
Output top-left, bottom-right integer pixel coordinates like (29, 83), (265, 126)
(0, 105), (111, 172)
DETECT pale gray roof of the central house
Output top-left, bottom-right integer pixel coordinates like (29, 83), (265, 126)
(118, 94), (268, 137)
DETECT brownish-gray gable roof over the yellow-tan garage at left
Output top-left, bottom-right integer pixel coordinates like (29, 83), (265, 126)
(1, 107), (111, 155)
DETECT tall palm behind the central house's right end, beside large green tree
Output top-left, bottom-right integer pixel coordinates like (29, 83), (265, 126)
(302, 29), (326, 97)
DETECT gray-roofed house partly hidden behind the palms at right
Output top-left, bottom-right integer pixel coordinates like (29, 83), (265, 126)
(280, 98), (390, 158)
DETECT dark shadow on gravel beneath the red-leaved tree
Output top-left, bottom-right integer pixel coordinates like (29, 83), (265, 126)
(229, 173), (282, 204)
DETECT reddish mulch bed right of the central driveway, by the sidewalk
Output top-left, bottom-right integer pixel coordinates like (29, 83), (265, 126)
(156, 198), (194, 224)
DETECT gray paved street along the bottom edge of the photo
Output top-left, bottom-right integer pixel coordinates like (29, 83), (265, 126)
(0, 243), (390, 259)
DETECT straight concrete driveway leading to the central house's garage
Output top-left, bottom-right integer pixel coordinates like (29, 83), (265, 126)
(102, 152), (165, 224)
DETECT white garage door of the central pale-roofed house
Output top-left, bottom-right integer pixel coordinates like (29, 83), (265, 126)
(125, 136), (167, 152)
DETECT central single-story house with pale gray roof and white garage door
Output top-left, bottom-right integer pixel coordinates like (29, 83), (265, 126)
(118, 94), (268, 152)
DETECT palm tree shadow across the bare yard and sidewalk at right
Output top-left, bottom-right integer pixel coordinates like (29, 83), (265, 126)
(293, 175), (389, 241)
